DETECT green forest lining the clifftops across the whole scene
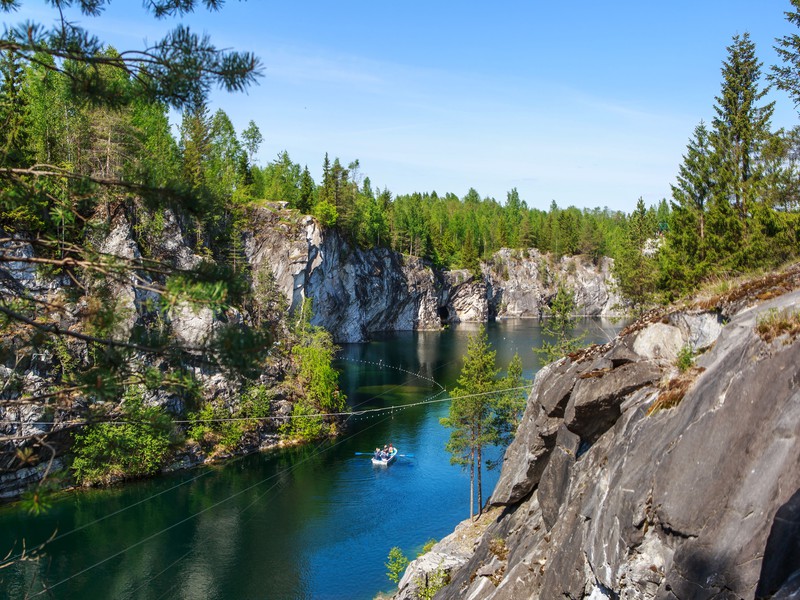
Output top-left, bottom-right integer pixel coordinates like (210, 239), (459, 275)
(0, 12), (800, 314)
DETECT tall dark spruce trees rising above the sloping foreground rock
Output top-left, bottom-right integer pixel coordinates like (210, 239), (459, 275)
(646, 31), (800, 302)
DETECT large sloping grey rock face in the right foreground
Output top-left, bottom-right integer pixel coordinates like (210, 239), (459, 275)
(394, 268), (800, 600)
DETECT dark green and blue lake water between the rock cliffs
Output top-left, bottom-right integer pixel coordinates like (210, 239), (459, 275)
(0, 320), (619, 600)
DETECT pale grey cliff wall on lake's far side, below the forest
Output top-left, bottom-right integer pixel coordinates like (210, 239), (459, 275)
(245, 204), (622, 342)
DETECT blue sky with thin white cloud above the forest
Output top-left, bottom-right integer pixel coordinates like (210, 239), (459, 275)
(3, 0), (798, 212)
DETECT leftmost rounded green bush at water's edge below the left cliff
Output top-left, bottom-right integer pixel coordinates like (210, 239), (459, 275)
(72, 388), (172, 485)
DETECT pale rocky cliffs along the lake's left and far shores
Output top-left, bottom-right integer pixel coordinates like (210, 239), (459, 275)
(0, 203), (621, 500)
